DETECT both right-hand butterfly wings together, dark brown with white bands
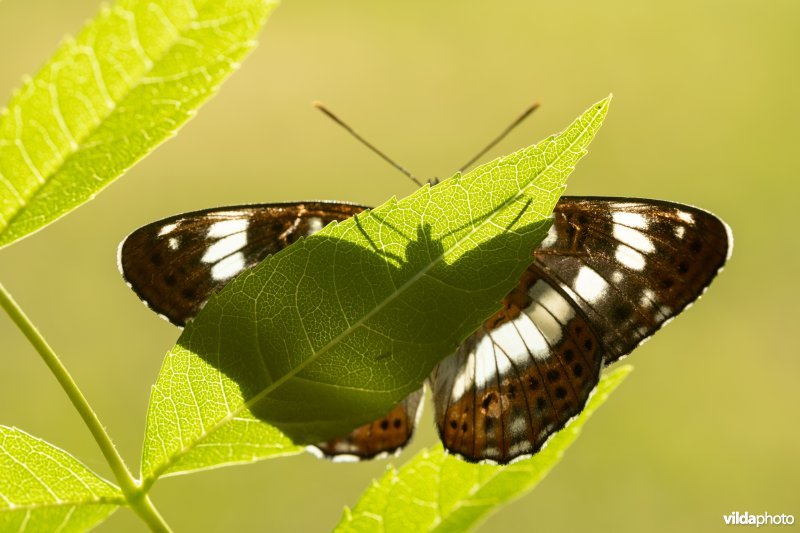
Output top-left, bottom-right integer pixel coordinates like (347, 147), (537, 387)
(431, 197), (732, 463)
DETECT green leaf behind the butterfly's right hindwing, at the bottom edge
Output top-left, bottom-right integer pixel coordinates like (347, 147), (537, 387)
(336, 366), (632, 533)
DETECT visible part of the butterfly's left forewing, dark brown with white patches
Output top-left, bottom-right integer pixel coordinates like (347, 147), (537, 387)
(119, 202), (365, 326)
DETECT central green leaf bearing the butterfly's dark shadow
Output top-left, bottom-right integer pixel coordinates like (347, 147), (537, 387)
(142, 95), (609, 477)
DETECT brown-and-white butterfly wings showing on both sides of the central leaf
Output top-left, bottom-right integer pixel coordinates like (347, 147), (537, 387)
(119, 196), (732, 464)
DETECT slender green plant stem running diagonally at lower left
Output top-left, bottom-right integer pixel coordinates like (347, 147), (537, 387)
(0, 283), (170, 531)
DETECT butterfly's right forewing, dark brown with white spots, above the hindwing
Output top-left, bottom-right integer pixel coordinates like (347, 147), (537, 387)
(531, 197), (730, 363)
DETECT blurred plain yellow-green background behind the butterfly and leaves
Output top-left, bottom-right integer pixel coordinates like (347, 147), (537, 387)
(0, 0), (800, 531)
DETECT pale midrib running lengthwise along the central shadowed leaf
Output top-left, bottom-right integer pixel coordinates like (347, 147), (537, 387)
(146, 106), (605, 483)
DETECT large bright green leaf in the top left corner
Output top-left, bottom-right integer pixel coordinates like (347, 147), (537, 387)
(0, 0), (275, 247)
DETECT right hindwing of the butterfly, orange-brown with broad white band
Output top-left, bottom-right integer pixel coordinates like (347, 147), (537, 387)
(430, 270), (604, 463)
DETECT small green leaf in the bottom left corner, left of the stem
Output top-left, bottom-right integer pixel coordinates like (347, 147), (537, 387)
(0, 426), (124, 531)
